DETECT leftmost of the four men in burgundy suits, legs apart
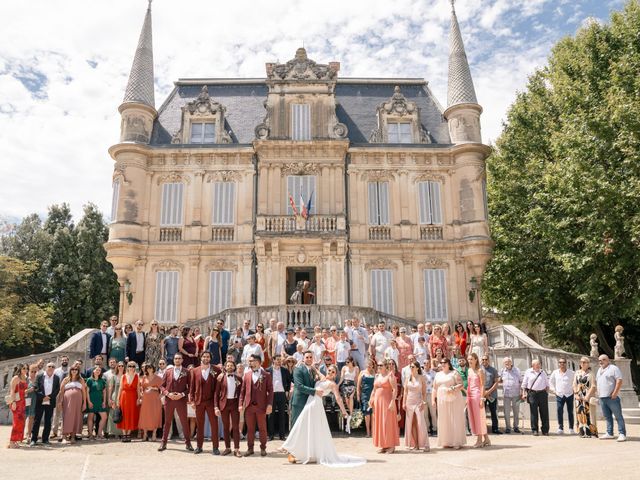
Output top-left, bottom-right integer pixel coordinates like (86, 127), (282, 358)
(158, 353), (193, 452)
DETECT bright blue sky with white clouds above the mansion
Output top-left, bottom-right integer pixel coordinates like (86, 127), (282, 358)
(0, 0), (624, 224)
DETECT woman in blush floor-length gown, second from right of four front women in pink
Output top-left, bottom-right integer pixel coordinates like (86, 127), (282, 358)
(432, 358), (467, 450)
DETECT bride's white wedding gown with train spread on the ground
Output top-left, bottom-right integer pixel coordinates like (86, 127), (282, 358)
(282, 380), (367, 467)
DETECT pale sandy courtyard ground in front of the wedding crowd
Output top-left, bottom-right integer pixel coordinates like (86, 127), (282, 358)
(0, 423), (640, 480)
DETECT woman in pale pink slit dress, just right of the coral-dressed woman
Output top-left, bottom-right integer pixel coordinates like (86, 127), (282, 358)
(402, 362), (429, 452)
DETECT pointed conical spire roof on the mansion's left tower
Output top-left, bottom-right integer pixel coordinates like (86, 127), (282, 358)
(122, 0), (155, 108)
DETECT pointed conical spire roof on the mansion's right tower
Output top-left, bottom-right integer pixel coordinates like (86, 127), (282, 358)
(447, 0), (478, 107)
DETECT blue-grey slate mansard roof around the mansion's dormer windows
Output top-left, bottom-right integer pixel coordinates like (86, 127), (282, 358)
(151, 79), (451, 147)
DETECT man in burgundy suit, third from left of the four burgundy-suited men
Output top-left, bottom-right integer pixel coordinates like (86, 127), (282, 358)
(214, 360), (242, 457)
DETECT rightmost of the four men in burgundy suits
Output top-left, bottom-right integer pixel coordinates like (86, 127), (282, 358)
(238, 355), (273, 457)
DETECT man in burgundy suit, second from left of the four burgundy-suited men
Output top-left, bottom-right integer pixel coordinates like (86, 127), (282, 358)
(189, 351), (220, 455)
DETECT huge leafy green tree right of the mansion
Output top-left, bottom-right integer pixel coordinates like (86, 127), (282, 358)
(484, 0), (640, 383)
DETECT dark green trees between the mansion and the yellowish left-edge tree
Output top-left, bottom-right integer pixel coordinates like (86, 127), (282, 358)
(0, 204), (119, 354)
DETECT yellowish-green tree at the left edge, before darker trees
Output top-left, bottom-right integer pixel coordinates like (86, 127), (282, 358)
(0, 255), (52, 359)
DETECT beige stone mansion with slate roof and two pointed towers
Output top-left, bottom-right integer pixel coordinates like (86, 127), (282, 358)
(105, 2), (492, 324)
